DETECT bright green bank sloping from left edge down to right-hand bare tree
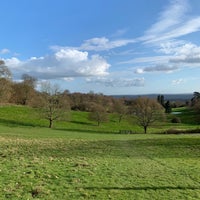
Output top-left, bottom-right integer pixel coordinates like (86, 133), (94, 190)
(0, 106), (143, 133)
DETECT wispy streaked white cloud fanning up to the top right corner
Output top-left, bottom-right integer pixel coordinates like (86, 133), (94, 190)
(140, 0), (200, 43)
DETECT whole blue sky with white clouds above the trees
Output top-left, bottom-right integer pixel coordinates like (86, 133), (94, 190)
(0, 0), (200, 95)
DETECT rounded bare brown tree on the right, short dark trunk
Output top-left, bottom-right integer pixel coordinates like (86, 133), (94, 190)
(133, 97), (163, 133)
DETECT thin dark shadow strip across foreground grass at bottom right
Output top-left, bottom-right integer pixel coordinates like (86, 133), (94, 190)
(83, 186), (200, 190)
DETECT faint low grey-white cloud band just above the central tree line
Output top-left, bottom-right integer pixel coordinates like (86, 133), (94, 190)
(87, 78), (145, 87)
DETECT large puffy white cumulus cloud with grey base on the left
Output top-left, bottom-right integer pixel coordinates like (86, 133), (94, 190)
(5, 48), (110, 79)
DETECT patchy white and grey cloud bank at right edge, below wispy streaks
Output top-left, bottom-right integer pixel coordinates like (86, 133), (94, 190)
(131, 40), (200, 74)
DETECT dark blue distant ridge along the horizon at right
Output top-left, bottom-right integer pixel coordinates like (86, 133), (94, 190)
(112, 93), (193, 101)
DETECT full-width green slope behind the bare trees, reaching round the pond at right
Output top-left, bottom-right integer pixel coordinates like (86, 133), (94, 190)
(0, 106), (198, 133)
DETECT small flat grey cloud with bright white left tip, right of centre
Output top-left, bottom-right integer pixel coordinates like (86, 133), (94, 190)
(135, 64), (179, 74)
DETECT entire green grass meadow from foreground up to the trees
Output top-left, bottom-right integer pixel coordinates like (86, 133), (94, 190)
(0, 106), (200, 200)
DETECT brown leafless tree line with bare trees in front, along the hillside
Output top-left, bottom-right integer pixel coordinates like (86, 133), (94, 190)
(0, 61), (200, 133)
